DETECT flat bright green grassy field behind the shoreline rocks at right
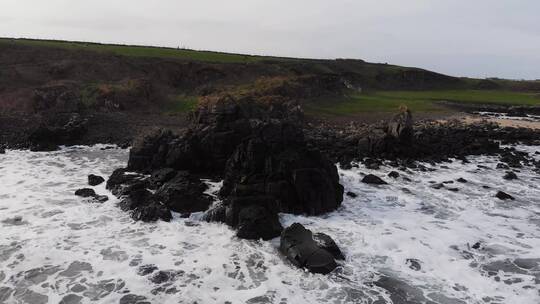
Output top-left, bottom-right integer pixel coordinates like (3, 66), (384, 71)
(305, 90), (540, 116)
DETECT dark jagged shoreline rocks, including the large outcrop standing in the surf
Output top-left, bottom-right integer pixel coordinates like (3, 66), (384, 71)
(48, 100), (540, 273)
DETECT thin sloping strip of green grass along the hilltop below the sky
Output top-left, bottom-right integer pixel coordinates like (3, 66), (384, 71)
(0, 38), (278, 63)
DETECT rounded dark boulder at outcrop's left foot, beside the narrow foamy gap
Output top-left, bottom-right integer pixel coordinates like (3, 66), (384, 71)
(155, 171), (212, 213)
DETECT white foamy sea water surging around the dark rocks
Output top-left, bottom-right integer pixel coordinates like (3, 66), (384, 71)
(0, 146), (540, 304)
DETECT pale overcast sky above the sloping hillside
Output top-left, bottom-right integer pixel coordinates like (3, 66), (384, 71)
(0, 0), (540, 79)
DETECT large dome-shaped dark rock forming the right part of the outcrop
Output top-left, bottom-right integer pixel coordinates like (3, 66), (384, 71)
(220, 122), (343, 215)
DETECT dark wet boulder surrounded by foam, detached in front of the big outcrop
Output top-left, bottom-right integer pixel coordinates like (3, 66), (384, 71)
(279, 223), (337, 274)
